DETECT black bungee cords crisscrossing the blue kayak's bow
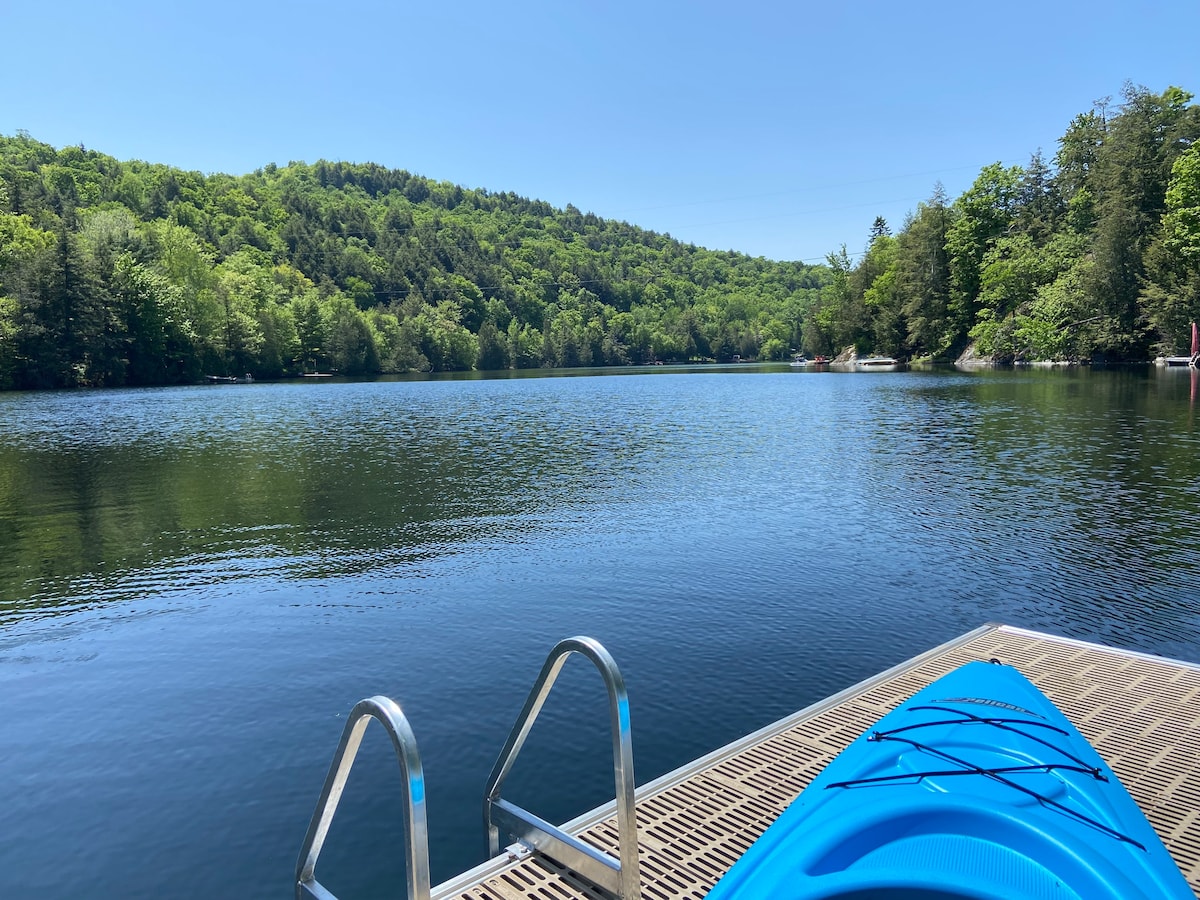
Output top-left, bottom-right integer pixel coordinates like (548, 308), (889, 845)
(826, 706), (1146, 851)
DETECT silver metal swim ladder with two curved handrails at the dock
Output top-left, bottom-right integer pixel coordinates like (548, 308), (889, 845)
(295, 637), (641, 900)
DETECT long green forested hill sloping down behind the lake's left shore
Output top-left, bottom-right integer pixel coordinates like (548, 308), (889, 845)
(0, 134), (828, 388)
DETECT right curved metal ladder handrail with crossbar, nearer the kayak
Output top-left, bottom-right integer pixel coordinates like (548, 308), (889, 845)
(484, 636), (641, 900)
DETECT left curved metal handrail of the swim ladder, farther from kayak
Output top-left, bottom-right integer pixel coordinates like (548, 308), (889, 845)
(296, 696), (430, 900)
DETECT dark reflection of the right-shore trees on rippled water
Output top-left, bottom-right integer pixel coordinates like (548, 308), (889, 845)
(883, 370), (1200, 646)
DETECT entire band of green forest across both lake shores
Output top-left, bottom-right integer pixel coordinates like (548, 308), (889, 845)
(0, 85), (1200, 388)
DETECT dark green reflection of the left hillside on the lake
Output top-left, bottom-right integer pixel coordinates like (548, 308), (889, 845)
(0, 383), (662, 622)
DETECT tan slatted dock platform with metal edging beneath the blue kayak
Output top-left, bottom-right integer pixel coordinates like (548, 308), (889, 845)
(432, 625), (1200, 900)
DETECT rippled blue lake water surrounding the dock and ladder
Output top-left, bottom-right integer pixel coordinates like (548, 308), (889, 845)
(0, 367), (1200, 900)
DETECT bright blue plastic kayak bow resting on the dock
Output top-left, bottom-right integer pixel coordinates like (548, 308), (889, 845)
(708, 662), (1194, 900)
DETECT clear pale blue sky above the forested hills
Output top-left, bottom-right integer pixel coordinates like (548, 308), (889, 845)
(0, 0), (1200, 262)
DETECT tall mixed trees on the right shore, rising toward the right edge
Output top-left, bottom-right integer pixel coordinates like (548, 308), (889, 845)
(802, 84), (1200, 361)
